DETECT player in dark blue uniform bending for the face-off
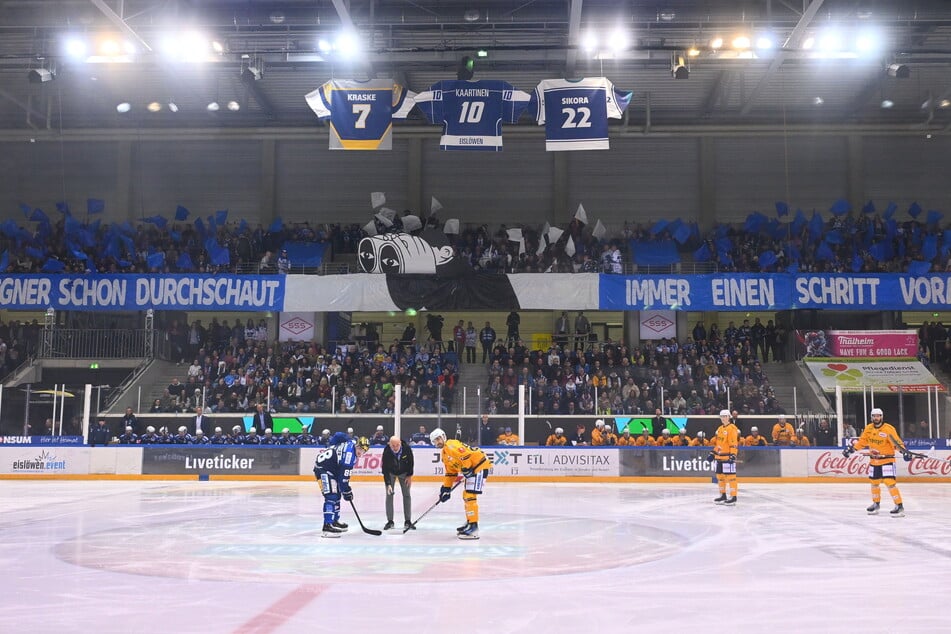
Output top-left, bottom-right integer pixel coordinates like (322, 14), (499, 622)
(314, 431), (370, 537)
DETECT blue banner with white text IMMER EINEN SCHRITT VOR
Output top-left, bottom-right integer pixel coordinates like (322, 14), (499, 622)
(599, 273), (951, 311)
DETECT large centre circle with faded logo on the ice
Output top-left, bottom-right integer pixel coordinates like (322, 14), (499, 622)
(55, 513), (687, 583)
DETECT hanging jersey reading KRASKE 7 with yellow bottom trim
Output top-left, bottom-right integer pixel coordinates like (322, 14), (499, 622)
(305, 79), (413, 150)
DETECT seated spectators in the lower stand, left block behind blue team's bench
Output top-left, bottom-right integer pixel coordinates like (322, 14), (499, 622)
(150, 318), (458, 414)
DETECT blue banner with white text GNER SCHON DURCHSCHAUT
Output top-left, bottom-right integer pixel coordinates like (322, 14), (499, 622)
(0, 275), (286, 311)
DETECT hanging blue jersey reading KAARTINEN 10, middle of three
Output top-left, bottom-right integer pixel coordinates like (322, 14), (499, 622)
(414, 80), (531, 152)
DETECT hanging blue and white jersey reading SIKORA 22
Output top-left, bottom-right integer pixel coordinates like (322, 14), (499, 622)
(531, 77), (631, 152)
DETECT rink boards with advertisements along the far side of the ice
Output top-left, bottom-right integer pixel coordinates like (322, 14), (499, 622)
(0, 445), (951, 482)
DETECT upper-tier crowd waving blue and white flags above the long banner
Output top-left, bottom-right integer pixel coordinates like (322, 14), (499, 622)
(0, 204), (951, 274)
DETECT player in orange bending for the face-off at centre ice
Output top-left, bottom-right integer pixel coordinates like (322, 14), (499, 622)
(429, 428), (492, 539)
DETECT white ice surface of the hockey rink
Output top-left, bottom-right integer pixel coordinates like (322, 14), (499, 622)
(0, 477), (951, 634)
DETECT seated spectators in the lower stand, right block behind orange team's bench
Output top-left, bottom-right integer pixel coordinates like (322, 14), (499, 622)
(485, 314), (783, 416)
